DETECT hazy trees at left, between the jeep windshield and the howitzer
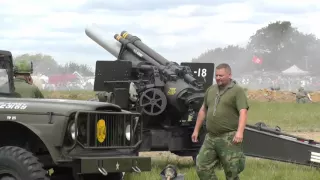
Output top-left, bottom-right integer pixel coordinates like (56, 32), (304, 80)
(14, 53), (94, 76)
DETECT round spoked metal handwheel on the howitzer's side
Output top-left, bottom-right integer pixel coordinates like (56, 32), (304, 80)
(139, 88), (167, 116)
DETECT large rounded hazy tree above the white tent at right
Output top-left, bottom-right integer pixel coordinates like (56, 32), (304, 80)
(247, 21), (320, 71)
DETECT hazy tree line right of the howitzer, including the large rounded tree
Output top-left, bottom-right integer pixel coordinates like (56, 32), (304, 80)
(192, 21), (320, 75)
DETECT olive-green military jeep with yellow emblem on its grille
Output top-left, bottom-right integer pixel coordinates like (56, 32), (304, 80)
(0, 51), (151, 180)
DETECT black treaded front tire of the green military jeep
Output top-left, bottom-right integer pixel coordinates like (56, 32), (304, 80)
(0, 146), (50, 180)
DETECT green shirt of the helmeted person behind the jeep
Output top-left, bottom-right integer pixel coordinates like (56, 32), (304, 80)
(14, 78), (44, 98)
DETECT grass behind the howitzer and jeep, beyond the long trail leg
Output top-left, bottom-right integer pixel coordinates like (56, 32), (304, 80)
(44, 91), (320, 132)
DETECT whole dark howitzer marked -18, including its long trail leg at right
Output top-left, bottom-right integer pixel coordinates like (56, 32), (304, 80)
(86, 26), (320, 171)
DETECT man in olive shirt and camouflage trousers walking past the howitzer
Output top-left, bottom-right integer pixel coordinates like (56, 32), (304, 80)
(192, 64), (249, 180)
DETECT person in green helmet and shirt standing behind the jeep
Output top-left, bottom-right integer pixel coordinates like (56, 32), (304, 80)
(14, 61), (44, 98)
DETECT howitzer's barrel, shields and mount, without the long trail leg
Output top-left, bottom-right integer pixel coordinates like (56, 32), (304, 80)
(85, 26), (214, 158)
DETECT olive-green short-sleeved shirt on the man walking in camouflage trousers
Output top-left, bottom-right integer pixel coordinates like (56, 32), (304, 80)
(204, 81), (249, 135)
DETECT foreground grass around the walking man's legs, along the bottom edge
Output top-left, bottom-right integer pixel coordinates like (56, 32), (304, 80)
(125, 155), (320, 180)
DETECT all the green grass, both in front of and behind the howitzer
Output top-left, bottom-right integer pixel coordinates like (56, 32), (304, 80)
(45, 92), (320, 180)
